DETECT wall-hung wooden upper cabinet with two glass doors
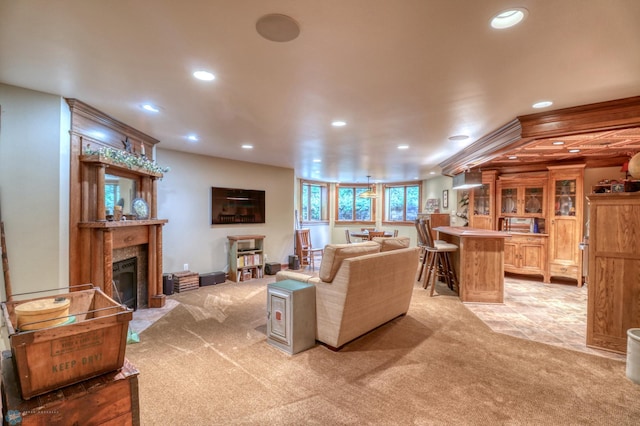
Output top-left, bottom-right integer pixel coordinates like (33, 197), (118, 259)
(497, 173), (547, 218)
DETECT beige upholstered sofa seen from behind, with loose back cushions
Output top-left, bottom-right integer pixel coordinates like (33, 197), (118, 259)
(276, 237), (419, 349)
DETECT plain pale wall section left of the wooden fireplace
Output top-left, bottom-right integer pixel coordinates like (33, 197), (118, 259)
(0, 84), (70, 300)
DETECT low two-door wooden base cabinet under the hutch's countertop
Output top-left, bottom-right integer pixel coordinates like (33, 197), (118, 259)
(504, 234), (549, 282)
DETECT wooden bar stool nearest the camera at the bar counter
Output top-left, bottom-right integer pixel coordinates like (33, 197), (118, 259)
(420, 220), (459, 296)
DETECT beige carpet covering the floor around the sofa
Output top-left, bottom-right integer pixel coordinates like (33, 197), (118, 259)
(127, 277), (640, 425)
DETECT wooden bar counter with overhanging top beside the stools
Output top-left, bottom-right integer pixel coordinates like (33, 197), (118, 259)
(434, 226), (511, 303)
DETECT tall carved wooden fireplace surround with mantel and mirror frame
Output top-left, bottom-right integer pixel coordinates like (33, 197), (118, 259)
(66, 99), (168, 308)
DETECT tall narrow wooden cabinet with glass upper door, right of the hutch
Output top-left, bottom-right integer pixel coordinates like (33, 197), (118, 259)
(547, 165), (584, 286)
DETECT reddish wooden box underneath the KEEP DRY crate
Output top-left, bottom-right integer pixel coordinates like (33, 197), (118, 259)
(2, 351), (140, 426)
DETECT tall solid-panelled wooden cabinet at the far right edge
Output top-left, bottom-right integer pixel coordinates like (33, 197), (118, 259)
(587, 192), (640, 353)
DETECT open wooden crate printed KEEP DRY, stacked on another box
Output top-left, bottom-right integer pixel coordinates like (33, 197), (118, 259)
(2, 287), (133, 399)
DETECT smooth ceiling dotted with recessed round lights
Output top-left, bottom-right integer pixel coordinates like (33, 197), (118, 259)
(0, 0), (640, 182)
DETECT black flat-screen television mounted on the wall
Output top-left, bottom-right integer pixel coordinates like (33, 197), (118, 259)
(211, 187), (265, 225)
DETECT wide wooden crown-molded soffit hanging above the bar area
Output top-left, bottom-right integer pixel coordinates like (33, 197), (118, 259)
(439, 96), (640, 176)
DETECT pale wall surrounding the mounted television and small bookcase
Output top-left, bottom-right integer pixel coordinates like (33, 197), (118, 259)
(156, 150), (295, 273)
